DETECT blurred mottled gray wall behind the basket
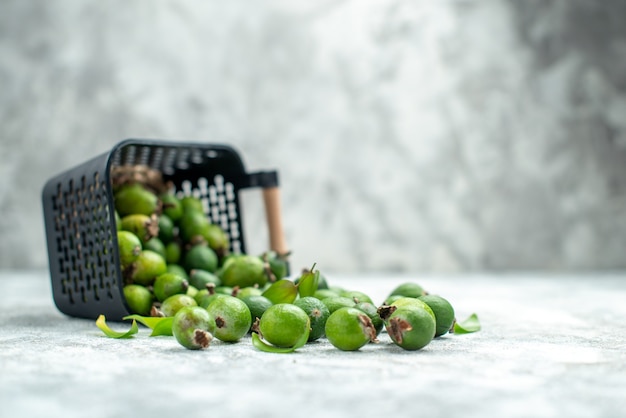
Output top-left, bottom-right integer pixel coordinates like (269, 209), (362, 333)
(0, 0), (626, 273)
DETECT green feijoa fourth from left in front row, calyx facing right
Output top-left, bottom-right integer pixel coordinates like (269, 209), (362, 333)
(325, 307), (378, 351)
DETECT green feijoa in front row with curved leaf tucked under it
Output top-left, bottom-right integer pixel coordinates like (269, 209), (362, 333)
(258, 303), (311, 347)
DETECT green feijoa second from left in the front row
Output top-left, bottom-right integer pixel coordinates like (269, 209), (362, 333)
(206, 295), (252, 342)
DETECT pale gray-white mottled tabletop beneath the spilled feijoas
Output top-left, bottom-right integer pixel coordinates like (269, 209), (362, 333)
(0, 272), (626, 418)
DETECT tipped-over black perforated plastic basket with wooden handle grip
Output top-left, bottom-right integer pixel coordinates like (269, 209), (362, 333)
(42, 139), (287, 321)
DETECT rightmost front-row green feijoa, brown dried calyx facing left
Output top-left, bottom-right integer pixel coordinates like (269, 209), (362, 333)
(385, 306), (436, 350)
